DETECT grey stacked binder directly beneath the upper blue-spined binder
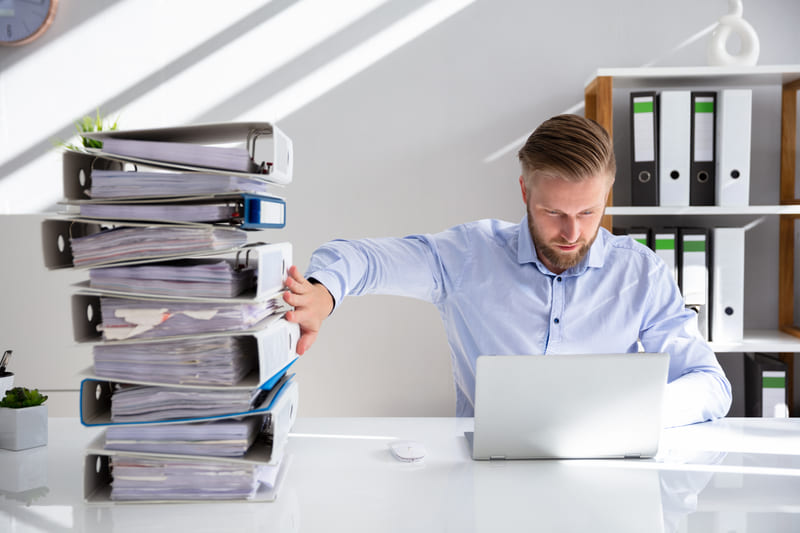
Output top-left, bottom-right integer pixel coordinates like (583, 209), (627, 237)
(42, 218), (248, 269)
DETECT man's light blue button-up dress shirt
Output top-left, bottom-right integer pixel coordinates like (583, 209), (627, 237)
(306, 217), (731, 426)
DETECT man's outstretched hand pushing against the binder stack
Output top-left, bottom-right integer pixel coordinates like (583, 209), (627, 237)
(283, 266), (333, 355)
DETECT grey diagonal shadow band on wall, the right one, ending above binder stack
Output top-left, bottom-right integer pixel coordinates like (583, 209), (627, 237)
(194, 0), (430, 123)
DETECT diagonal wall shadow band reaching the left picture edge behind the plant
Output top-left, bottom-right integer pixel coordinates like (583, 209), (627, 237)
(0, 0), (298, 183)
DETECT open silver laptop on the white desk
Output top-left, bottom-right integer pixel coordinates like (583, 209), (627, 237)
(465, 353), (669, 459)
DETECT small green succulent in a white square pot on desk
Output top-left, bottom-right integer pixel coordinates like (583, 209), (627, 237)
(0, 387), (47, 450)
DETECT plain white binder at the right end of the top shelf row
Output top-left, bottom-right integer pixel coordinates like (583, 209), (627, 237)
(716, 89), (753, 206)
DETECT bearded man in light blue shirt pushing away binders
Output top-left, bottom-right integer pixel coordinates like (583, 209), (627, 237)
(284, 115), (731, 426)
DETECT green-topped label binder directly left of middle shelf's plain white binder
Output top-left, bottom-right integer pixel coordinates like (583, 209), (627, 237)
(678, 228), (710, 340)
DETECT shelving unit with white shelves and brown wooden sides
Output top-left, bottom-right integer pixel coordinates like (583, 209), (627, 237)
(584, 65), (800, 415)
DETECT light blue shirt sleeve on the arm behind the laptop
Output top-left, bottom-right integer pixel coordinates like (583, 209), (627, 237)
(640, 260), (731, 427)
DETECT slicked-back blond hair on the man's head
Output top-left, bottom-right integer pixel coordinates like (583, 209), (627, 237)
(519, 115), (617, 186)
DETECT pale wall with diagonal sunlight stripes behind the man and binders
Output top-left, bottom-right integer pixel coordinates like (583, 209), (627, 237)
(0, 0), (800, 416)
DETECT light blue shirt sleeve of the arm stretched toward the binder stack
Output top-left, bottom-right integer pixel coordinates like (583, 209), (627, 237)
(306, 227), (471, 310)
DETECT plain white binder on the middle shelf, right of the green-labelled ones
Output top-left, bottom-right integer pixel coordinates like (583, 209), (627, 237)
(711, 228), (745, 342)
